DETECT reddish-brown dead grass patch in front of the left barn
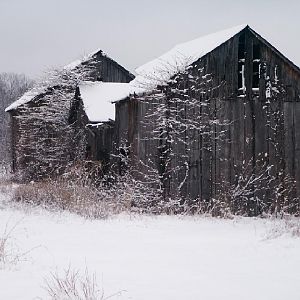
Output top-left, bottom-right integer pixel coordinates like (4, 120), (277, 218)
(13, 180), (126, 219)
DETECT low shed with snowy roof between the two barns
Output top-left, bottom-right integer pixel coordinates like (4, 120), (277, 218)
(70, 81), (130, 172)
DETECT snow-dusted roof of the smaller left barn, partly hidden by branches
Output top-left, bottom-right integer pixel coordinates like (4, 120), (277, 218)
(5, 49), (134, 112)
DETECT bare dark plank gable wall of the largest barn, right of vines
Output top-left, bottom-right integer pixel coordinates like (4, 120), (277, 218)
(189, 27), (300, 214)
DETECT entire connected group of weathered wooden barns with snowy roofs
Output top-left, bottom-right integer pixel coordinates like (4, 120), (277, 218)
(7, 25), (300, 215)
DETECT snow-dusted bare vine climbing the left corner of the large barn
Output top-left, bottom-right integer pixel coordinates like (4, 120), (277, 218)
(132, 65), (229, 202)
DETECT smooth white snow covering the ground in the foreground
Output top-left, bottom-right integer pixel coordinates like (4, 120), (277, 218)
(0, 198), (300, 300)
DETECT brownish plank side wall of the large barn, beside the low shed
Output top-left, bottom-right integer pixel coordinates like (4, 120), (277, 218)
(114, 97), (159, 188)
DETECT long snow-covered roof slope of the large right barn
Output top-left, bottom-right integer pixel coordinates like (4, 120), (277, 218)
(131, 24), (247, 90)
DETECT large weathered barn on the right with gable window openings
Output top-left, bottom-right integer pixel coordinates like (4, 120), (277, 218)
(115, 25), (300, 215)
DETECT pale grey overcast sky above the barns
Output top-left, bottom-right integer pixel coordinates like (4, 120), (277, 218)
(0, 0), (300, 78)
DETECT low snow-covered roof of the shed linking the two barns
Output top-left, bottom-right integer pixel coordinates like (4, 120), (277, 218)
(79, 81), (131, 122)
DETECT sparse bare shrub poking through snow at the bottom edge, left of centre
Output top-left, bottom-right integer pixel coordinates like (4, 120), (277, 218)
(45, 267), (121, 300)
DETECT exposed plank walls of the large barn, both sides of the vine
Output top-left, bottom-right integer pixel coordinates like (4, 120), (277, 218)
(116, 29), (300, 214)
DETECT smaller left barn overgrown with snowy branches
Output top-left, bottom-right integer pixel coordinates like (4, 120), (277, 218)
(6, 50), (134, 180)
